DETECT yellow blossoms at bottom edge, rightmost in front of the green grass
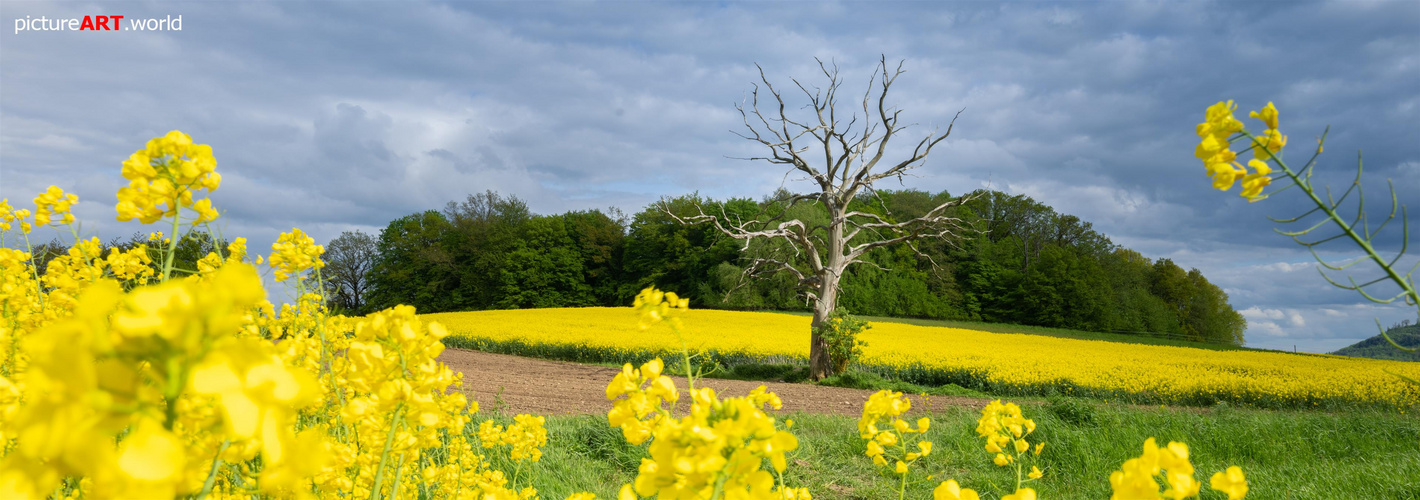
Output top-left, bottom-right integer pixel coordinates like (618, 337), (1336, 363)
(1109, 438), (1247, 500)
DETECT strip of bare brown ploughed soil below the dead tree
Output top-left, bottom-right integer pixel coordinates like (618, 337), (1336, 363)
(439, 349), (987, 416)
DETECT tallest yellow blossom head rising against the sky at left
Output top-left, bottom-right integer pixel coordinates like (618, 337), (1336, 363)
(116, 131), (222, 224)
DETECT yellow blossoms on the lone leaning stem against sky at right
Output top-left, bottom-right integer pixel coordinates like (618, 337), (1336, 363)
(1193, 101), (1287, 202)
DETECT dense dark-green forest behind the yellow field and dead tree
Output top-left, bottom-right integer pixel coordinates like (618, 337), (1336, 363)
(352, 190), (1245, 345)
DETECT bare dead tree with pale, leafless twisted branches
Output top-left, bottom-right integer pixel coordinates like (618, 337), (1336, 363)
(663, 57), (971, 379)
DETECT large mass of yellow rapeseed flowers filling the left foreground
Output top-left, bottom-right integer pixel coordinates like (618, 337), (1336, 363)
(0, 132), (604, 499)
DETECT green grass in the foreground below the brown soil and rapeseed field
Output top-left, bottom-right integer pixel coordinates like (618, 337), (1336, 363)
(502, 399), (1420, 499)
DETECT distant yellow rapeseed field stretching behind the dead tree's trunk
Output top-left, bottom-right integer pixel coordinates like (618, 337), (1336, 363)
(425, 308), (1420, 408)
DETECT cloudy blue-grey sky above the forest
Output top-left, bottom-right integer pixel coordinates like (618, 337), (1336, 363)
(0, 0), (1420, 352)
